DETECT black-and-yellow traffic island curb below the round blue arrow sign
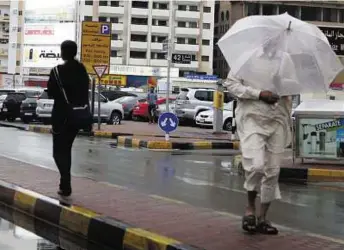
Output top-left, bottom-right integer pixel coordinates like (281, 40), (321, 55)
(115, 136), (239, 150)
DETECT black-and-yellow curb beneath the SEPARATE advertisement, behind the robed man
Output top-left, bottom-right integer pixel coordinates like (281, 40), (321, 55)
(233, 155), (344, 181)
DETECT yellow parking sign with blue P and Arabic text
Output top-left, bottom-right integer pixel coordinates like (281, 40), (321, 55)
(81, 21), (111, 75)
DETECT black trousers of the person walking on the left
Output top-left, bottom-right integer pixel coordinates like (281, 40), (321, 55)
(53, 128), (79, 191)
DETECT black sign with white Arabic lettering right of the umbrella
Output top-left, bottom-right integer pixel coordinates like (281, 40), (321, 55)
(319, 27), (344, 56)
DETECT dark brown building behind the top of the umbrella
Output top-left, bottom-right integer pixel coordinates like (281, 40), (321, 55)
(213, 1), (344, 78)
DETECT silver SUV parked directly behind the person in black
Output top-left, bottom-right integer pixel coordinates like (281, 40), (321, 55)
(36, 91), (124, 125)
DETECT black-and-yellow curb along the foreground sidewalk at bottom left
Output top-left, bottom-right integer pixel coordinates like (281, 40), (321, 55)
(0, 181), (197, 250)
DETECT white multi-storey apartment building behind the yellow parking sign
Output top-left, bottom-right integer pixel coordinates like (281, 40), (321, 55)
(80, 0), (215, 77)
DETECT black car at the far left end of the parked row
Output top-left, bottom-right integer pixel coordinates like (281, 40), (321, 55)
(1, 92), (26, 122)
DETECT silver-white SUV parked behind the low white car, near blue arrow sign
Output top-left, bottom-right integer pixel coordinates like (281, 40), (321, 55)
(175, 88), (233, 121)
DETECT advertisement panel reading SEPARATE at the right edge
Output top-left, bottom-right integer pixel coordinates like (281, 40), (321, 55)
(298, 118), (344, 159)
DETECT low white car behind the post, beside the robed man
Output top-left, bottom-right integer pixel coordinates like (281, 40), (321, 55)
(195, 102), (233, 131)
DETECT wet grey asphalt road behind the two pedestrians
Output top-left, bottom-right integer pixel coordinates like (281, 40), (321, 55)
(0, 128), (344, 239)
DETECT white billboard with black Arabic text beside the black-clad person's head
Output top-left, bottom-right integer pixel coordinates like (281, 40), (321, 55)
(23, 45), (63, 68)
